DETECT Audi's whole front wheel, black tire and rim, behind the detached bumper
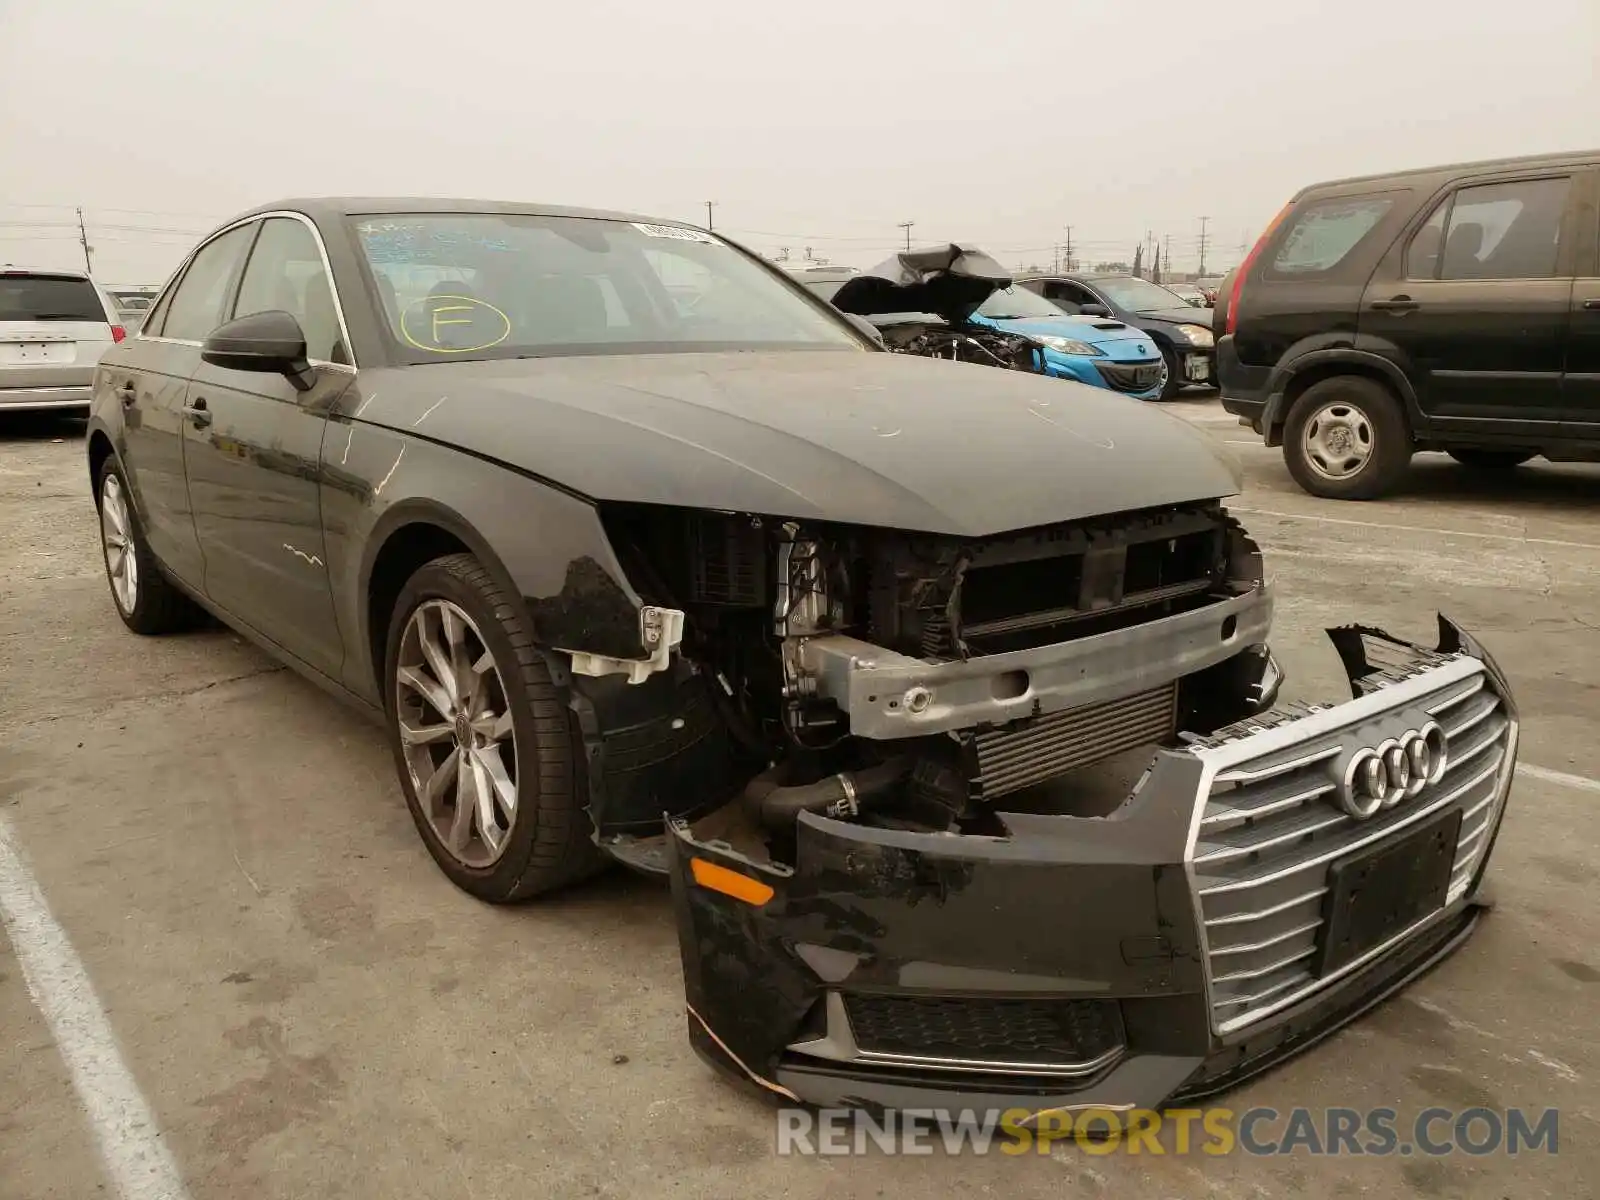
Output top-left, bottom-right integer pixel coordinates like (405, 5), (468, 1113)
(384, 554), (603, 904)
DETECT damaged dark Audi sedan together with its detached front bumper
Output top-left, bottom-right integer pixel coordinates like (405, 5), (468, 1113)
(88, 200), (1517, 1112)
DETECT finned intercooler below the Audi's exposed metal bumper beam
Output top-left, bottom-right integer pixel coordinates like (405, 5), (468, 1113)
(960, 683), (1178, 800)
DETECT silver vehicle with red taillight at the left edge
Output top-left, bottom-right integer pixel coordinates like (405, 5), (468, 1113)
(0, 266), (126, 413)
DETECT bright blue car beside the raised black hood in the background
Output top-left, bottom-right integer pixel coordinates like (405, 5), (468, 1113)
(966, 286), (1166, 400)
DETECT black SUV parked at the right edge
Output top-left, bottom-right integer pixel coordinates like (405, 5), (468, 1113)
(1213, 150), (1600, 499)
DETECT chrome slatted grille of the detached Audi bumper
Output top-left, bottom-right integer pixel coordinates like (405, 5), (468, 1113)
(1190, 656), (1515, 1034)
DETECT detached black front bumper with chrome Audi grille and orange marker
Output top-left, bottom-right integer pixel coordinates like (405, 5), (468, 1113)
(669, 618), (1517, 1114)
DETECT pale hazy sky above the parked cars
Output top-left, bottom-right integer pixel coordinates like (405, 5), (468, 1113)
(0, 0), (1600, 283)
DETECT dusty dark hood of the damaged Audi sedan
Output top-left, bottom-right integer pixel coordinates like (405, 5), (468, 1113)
(362, 350), (1240, 536)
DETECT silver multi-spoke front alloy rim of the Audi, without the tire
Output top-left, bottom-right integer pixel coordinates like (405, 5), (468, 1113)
(395, 600), (517, 867)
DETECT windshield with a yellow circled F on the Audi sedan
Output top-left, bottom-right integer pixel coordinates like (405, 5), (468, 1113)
(352, 213), (862, 363)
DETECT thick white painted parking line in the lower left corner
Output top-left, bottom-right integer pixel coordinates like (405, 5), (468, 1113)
(0, 819), (187, 1200)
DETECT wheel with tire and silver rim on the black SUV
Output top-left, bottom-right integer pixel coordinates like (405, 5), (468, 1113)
(1283, 374), (1413, 499)
